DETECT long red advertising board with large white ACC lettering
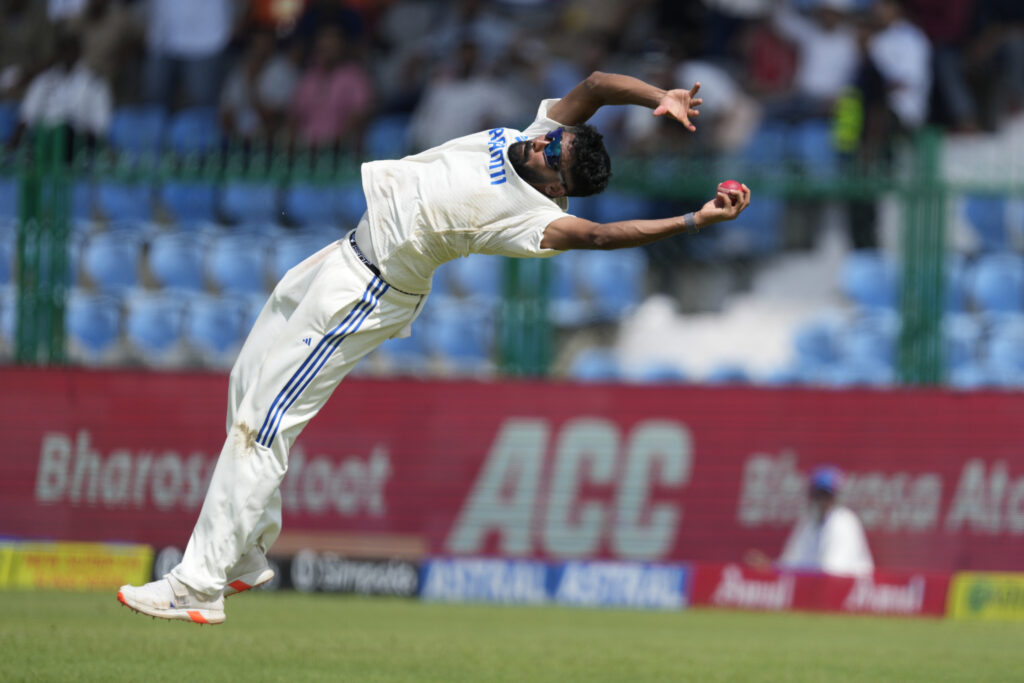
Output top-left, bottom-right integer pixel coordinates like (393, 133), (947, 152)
(0, 369), (1024, 571)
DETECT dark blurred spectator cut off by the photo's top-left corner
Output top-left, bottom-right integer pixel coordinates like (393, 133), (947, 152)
(0, 0), (54, 101)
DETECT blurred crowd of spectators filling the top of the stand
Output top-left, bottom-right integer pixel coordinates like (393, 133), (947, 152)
(0, 0), (1024, 153)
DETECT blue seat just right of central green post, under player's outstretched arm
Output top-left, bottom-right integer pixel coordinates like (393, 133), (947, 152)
(577, 249), (647, 322)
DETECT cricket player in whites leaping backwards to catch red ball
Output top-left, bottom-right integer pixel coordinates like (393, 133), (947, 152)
(118, 72), (750, 624)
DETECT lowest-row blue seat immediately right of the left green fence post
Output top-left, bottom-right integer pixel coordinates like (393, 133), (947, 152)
(65, 289), (122, 366)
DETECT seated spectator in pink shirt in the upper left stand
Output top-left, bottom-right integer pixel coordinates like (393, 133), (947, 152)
(291, 25), (373, 155)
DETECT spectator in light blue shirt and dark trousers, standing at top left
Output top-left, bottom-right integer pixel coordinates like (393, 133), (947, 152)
(142, 0), (242, 109)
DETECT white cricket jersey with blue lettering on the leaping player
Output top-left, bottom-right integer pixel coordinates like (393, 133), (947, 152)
(362, 99), (568, 294)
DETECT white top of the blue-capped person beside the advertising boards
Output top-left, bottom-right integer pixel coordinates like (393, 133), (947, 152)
(778, 505), (874, 575)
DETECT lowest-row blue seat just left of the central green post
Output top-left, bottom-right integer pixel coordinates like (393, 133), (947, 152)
(418, 299), (495, 369)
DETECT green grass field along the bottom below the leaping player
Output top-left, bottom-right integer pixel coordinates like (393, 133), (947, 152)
(0, 592), (1024, 682)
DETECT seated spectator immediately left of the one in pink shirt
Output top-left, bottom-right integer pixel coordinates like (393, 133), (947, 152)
(220, 29), (298, 142)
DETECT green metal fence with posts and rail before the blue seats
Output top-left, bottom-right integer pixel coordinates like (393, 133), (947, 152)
(0, 130), (956, 384)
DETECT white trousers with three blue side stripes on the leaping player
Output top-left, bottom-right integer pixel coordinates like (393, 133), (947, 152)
(171, 232), (424, 594)
